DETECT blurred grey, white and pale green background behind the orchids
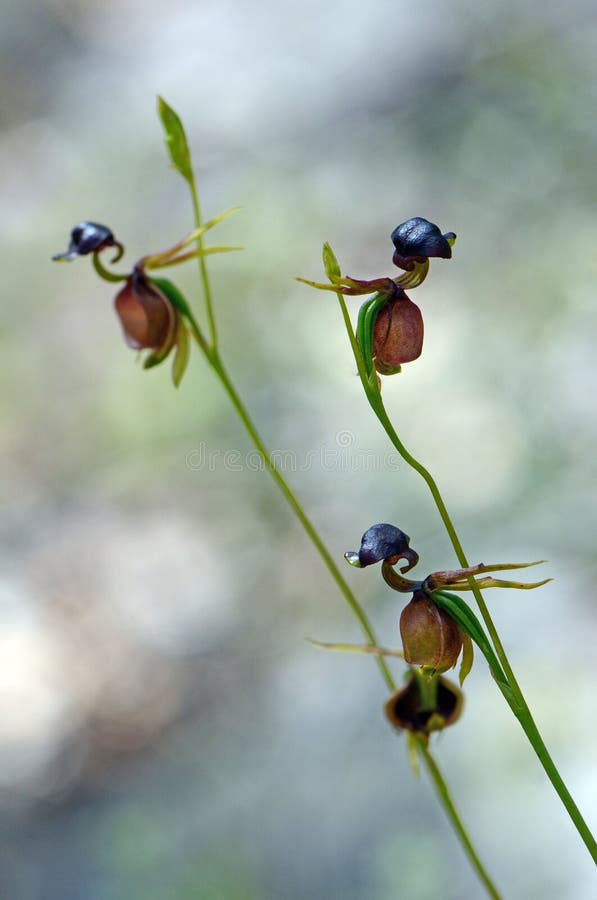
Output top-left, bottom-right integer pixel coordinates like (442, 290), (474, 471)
(0, 0), (597, 900)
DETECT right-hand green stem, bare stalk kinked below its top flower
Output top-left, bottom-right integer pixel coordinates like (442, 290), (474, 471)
(336, 292), (597, 863)
